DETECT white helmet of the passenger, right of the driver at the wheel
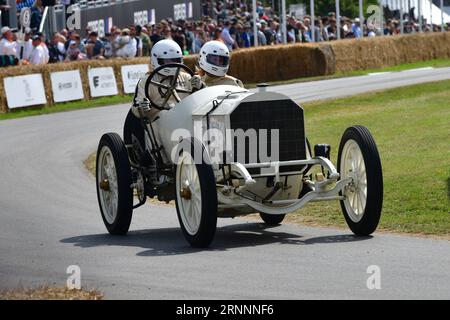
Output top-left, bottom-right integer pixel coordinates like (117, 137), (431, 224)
(198, 41), (230, 77)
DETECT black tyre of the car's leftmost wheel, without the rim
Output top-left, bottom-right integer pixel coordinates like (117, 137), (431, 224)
(95, 133), (133, 235)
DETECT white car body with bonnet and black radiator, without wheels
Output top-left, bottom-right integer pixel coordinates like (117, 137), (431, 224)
(153, 86), (339, 217)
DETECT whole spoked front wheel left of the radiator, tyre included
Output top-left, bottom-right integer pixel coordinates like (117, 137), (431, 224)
(176, 139), (217, 248)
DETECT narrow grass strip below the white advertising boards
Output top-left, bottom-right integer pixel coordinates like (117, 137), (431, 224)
(0, 95), (132, 120)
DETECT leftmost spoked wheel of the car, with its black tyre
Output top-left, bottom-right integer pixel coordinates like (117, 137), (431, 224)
(96, 133), (133, 235)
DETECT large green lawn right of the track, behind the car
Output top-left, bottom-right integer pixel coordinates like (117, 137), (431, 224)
(290, 81), (450, 237)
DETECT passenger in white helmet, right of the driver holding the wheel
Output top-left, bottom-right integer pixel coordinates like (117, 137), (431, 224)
(192, 40), (244, 88)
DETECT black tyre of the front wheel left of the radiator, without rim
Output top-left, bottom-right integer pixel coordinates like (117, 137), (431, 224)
(175, 140), (218, 248)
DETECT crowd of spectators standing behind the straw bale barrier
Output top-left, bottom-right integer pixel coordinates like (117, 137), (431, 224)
(0, 0), (448, 65)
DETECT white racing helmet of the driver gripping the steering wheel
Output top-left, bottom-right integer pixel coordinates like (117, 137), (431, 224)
(150, 39), (183, 76)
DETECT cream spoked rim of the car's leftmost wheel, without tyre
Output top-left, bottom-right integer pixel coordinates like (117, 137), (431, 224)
(97, 146), (119, 224)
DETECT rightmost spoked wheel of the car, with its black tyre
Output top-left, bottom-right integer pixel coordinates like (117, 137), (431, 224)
(337, 126), (383, 236)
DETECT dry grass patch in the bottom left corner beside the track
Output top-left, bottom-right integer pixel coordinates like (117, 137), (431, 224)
(0, 286), (103, 300)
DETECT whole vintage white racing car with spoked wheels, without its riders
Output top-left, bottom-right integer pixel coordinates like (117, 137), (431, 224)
(96, 64), (383, 247)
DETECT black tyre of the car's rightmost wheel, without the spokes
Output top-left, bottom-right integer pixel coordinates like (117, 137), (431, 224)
(337, 126), (383, 236)
